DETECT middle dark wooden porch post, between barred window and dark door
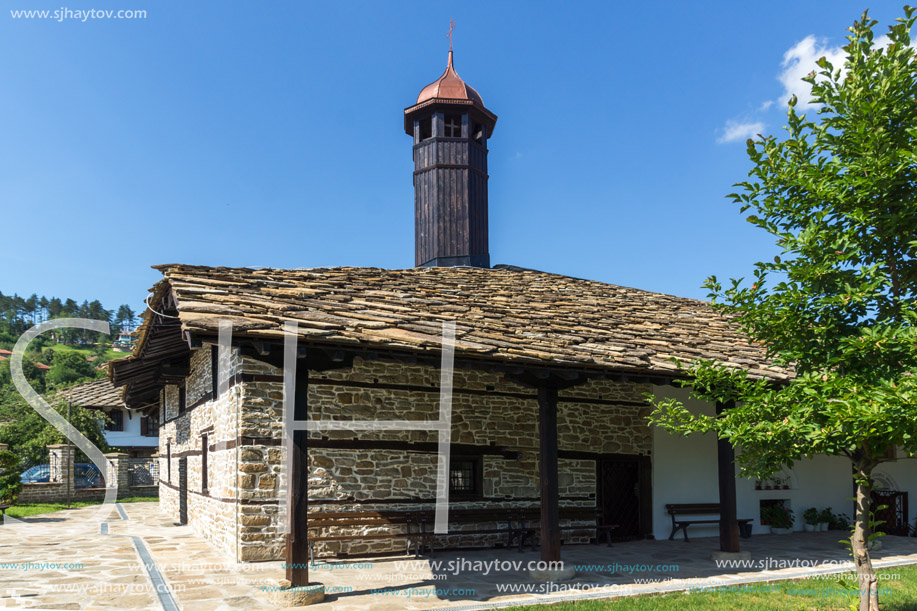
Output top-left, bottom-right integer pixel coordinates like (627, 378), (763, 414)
(538, 385), (560, 562)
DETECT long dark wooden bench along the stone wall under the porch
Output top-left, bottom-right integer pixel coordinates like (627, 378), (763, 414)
(309, 507), (618, 561)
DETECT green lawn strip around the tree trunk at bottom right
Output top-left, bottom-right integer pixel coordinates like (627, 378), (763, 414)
(515, 565), (917, 611)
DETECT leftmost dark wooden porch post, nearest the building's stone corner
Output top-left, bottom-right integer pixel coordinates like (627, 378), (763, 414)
(287, 367), (309, 588)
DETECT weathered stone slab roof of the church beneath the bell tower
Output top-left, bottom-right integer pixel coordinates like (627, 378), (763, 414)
(134, 265), (789, 379)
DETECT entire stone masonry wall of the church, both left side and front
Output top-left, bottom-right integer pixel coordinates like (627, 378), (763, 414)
(160, 346), (652, 561)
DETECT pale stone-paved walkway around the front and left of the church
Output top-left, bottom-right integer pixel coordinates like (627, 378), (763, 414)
(0, 503), (917, 611)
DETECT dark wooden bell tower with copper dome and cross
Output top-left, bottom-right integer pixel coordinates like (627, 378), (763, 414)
(404, 43), (497, 267)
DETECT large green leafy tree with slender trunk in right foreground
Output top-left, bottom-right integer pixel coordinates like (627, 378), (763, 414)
(651, 7), (917, 611)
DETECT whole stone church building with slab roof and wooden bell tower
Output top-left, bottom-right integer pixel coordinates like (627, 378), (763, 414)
(110, 51), (917, 561)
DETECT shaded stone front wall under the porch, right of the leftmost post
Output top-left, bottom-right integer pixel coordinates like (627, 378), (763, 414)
(296, 359), (652, 554)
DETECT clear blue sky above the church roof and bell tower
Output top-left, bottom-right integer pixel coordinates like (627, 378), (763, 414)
(0, 0), (901, 316)
